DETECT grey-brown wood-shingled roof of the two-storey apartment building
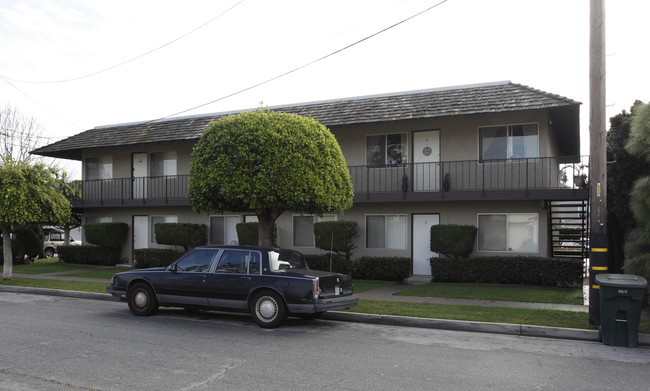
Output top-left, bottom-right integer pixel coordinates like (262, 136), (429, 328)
(32, 81), (580, 160)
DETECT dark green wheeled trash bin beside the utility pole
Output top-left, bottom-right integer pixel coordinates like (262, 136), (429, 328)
(596, 274), (648, 348)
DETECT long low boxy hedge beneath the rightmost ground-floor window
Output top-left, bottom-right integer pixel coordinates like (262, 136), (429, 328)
(430, 256), (584, 286)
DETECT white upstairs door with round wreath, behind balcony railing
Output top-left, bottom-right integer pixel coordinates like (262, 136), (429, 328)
(413, 130), (440, 191)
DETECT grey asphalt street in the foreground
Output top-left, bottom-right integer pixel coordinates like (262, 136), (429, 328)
(0, 292), (650, 391)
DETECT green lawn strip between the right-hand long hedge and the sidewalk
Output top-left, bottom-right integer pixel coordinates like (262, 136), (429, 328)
(394, 282), (583, 305)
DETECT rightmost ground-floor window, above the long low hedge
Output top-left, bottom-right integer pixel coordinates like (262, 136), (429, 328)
(478, 213), (539, 253)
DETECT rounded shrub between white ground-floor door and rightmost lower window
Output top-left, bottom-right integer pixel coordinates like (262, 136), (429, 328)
(431, 224), (477, 259)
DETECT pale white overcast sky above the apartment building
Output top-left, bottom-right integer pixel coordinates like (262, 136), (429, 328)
(0, 0), (650, 179)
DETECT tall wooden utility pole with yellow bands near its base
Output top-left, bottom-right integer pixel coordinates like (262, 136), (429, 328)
(589, 0), (607, 325)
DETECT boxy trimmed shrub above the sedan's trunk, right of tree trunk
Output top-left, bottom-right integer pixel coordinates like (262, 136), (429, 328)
(314, 221), (357, 260)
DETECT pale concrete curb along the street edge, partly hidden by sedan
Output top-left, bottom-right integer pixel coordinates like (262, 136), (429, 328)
(0, 285), (650, 346)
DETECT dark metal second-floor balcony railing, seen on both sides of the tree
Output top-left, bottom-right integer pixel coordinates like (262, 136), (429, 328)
(72, 156), (589, 207)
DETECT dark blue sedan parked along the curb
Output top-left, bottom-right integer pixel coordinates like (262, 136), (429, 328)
(106, 246), (359, 328)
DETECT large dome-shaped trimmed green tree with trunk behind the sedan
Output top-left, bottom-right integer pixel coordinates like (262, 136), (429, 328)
(189, 108), (352, 246)
